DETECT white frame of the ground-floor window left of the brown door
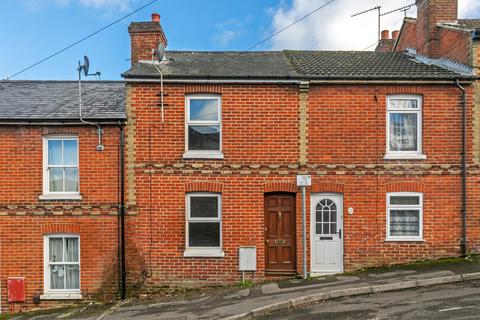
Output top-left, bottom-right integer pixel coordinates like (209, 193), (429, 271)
(183, 192), (225, 258)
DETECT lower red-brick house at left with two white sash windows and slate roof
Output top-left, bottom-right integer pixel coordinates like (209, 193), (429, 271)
(0, 81), (126, 312)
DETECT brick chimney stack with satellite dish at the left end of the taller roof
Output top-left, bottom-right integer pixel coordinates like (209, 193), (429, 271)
(128, 13), (167, 66)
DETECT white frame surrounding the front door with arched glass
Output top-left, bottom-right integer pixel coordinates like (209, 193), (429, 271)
(310, 193), (345, 276)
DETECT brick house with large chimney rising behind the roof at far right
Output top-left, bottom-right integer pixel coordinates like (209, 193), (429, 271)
(393, 0), (480, 165)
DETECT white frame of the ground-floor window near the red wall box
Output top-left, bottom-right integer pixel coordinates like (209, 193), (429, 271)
(40, 233), (82, 300)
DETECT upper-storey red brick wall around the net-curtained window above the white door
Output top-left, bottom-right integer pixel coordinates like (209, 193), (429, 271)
(309, 85), (472, 165)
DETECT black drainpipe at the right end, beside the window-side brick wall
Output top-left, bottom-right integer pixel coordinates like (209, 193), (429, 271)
(455, 79), (467, 257)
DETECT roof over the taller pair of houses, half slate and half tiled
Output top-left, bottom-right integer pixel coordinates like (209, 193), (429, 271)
(122, 51), (472, 81)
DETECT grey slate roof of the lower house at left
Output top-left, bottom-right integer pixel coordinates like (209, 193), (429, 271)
(0, 81), (126, 121)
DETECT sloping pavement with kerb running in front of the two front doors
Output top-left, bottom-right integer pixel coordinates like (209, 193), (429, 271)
(95, 260), (480, 320)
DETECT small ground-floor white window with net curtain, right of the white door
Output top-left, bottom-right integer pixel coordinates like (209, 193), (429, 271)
(387, 192), (423, 241)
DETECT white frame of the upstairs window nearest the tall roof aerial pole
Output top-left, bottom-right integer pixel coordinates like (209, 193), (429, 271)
(183, 94), (223, 159)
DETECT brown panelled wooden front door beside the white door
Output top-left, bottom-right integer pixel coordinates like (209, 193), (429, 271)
(265, 194), (296, 274)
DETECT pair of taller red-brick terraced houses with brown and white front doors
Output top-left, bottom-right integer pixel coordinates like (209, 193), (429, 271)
(123, 14), (480, 290)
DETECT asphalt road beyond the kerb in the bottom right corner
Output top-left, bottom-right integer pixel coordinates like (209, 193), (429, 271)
(262, 281), (480, 320)
